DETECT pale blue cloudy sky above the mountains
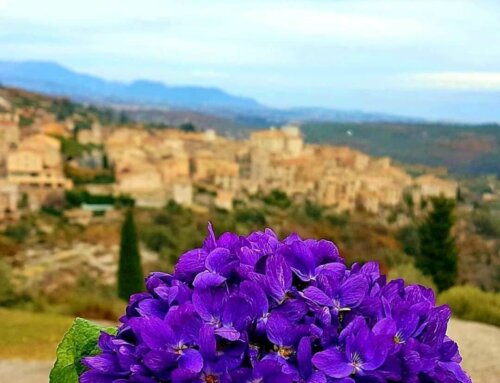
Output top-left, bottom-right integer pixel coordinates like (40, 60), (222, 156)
(0, 0), (500, 121)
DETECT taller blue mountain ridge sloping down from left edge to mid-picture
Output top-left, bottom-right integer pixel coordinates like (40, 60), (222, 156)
(0, 61), (261, 110)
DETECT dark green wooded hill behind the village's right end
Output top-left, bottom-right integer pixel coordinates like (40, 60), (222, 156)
(303, 123), (500, 176)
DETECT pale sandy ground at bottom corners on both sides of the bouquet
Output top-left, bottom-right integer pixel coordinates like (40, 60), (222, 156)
(0, 320), (500, 383)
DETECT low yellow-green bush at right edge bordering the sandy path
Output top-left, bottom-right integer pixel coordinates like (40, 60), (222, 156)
(438, 286), (500, 326)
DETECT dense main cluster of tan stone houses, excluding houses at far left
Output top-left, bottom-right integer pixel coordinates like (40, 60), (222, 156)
(104, 126), (457, 213)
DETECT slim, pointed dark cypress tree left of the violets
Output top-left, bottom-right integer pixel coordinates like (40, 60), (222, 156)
(118, 209), (144, 300)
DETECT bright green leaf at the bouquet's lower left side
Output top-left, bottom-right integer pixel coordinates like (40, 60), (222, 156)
(49, 318), (116, 383)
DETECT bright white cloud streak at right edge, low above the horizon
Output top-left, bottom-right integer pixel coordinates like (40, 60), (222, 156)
(403, 72), (500, 91)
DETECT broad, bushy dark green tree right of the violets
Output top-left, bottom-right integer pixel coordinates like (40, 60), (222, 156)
(416, 197), (457, 291)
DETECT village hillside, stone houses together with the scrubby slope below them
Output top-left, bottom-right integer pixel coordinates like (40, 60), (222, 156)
(0, 87), (499, 296)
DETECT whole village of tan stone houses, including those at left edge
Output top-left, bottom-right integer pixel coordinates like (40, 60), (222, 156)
(0, 91), (457, 224)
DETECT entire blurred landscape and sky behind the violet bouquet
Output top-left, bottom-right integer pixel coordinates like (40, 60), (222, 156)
(0, 0), (500, 383)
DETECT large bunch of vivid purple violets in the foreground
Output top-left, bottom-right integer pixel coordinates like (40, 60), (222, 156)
(53, 226), (471, 383)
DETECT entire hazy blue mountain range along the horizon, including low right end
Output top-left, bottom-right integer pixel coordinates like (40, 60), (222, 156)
(0, 61), (422, 127)
